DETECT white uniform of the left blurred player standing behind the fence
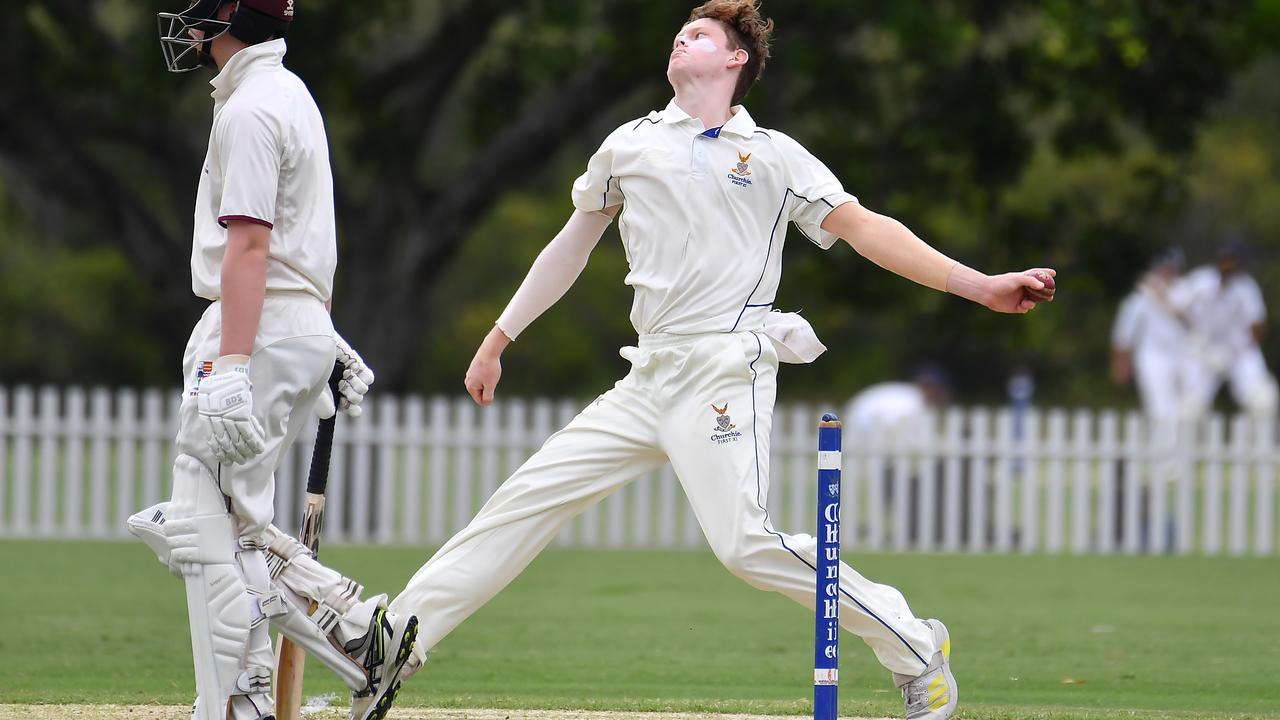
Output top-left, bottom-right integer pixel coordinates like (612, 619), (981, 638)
(1111, 281), (1197, 419)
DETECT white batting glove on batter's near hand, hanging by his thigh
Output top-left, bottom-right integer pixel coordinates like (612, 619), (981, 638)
(197, 355), (265, 465)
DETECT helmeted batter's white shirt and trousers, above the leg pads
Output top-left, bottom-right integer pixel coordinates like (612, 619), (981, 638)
(178, 40), (338, 536)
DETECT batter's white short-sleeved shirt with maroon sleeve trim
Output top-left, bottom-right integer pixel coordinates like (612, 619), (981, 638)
(191, 40), (338, 301)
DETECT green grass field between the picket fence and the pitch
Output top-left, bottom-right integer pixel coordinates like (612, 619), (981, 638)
(0, 541), (1280, 720)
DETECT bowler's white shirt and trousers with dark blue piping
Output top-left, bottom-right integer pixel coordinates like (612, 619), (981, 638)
(390, 102), (934, 675)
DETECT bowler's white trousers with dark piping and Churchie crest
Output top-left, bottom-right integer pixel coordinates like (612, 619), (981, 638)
(390, 332), (936, 675)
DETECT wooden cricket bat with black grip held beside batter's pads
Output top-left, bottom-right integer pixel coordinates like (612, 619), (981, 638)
(275, 363), (343, 720)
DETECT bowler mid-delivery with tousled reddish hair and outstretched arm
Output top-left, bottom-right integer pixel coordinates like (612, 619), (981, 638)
(366, 0), (1053, 719)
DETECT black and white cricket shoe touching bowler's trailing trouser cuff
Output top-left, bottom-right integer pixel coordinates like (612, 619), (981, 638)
(344, 607), (417, 720)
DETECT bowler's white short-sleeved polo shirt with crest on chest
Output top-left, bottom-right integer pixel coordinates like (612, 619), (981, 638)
(573, 101), (856, 334)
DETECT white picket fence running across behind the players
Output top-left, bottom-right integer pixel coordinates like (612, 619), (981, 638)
(0, 387), (1280, 555)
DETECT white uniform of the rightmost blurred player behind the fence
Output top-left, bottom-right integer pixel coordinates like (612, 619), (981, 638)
(1178, 265), (1276, 414)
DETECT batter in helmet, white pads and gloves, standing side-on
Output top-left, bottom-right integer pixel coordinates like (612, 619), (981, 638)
(129, 0), (417, 720)
